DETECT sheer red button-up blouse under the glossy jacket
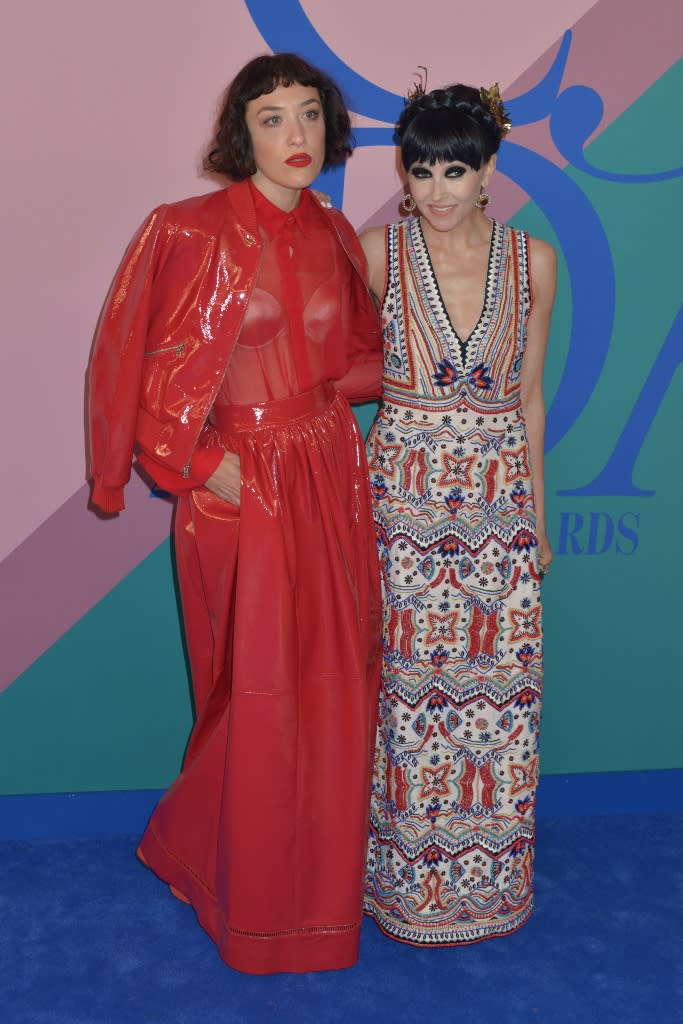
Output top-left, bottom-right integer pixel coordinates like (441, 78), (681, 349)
(147, 181), (382, 495)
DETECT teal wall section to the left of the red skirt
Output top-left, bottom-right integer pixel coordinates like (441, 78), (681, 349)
(0, 542), (191, 795)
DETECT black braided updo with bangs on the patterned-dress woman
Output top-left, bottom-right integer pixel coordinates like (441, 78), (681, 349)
(396, 85), (503, 171)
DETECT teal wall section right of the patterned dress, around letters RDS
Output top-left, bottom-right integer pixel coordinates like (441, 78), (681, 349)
(514, 63), (683, 774)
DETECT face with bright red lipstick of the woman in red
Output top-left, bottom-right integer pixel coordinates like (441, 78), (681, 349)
(245, 82), (325, 209)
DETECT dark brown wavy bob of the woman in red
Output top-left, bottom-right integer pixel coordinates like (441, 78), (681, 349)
(204, 53), (352, 181)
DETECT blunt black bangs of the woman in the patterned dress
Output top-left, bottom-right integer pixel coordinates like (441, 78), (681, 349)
(400, 109), (493, 171)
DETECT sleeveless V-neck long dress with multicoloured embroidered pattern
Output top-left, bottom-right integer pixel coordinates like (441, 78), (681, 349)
(365, 218), (543, 945)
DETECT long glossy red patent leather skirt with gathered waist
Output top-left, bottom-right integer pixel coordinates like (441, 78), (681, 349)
(140, 385), (381, 974)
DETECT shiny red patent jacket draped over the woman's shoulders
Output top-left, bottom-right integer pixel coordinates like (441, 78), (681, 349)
(89, 181), (382, 512)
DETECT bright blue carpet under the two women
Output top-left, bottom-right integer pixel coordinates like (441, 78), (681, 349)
(0, 813), (683, 1024)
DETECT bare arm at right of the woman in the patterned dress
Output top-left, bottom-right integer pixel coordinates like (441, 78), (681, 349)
(521, 239), (557, 569)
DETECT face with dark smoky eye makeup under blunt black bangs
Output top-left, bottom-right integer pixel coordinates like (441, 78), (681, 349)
(408, 156), (496, 231)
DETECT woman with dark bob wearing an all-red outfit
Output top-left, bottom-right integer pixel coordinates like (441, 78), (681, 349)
(90, 53), (382, 974)
